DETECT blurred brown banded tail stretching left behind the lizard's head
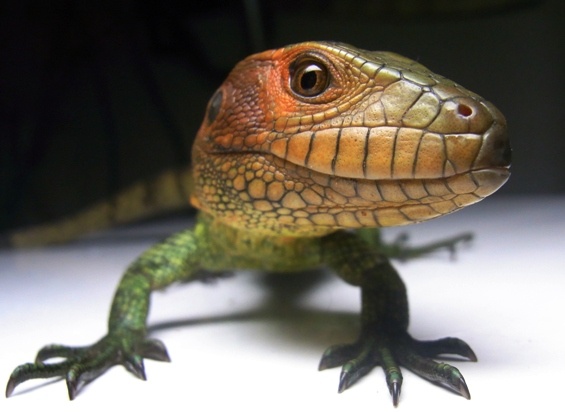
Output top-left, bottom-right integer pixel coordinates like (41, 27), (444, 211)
(8, 167), (192, 248)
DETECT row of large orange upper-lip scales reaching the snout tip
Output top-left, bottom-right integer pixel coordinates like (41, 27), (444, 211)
(267, 122), (511, 185)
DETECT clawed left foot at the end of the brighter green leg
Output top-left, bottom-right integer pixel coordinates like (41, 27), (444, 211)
(6, 331), (170, 400)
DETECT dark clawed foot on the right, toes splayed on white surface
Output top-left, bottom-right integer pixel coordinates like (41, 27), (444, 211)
(319, 330), (477, 406)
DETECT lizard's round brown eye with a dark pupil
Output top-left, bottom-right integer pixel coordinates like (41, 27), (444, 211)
(290, 58), (330, 97)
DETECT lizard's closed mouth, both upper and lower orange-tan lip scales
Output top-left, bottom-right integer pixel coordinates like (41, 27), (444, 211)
(260, 122), (511, 228)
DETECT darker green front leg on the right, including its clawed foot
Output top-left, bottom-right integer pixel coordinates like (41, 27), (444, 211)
(319, 233), (476, 406)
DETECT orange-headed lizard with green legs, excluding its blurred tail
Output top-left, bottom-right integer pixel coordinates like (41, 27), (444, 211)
(6, 42), (511, 406)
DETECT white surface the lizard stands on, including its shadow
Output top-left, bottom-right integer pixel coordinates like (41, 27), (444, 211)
(0, 196), (565, 412)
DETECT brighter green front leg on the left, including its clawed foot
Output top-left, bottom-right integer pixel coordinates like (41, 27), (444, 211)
(6, 226), (206, 400)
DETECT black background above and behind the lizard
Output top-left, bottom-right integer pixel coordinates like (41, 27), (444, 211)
(0, 0), (565, 229)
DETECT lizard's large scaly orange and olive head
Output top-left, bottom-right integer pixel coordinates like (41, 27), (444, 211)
(193, 42), (511, 236)
